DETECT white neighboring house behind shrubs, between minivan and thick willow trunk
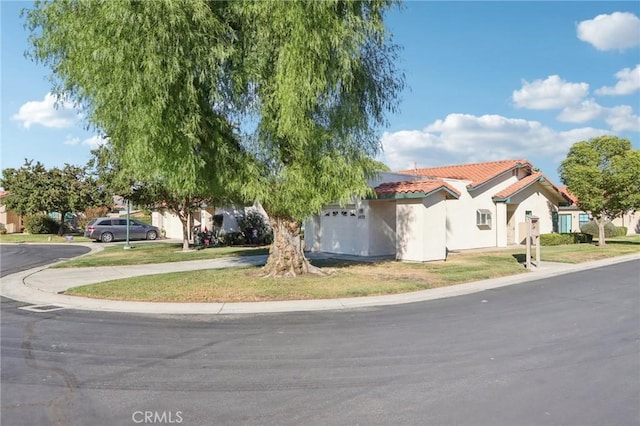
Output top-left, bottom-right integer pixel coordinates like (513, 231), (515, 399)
(151, 204), (269, 239)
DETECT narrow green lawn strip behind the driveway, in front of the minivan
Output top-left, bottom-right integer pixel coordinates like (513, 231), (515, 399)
(54, 242), (269, 268)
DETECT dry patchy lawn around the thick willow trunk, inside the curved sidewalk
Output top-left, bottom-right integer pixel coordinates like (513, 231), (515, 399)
(65, 250), (526, 302)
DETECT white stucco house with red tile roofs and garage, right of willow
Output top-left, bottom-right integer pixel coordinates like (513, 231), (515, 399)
(305, 160), (567, 261)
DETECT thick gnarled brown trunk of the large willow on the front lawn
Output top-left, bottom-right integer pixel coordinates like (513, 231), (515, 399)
(263, 217), (325, 277)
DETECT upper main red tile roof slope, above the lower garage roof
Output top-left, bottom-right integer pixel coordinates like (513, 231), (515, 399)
(400, 160), (531, 188)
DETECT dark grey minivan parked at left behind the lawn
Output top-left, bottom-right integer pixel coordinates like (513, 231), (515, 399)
(84, 217), (160, 243)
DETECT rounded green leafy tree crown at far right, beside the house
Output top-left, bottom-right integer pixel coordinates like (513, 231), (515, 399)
(558, 136), (640, 218)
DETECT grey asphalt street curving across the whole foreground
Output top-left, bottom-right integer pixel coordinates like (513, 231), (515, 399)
(0, 261), (640, 426)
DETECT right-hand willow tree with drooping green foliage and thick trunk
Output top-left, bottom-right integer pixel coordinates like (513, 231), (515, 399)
(233, 0), (402, 276)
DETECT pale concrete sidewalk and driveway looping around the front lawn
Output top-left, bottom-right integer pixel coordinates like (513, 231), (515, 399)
(0, 254), (640, 314)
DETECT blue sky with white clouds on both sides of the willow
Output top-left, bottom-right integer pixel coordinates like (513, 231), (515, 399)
(0, 1), (640, 184)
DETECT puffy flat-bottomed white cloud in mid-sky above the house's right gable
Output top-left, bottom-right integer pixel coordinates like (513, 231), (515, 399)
(512, 75), (589, 109)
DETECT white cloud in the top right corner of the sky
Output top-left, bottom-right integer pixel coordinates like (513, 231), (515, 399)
(577, 12), (640, 50)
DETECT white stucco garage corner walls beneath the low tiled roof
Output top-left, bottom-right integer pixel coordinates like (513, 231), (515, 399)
(396, 192), (447, 262)
